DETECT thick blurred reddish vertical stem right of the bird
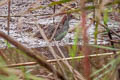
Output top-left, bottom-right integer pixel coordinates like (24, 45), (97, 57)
(81, 11), (91, 80)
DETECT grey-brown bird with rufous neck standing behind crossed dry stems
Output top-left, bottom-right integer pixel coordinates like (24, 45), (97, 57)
(33, 14), (74, 41)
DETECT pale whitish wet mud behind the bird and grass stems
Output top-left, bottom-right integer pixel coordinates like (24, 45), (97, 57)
(0, 0), (120, 48)
